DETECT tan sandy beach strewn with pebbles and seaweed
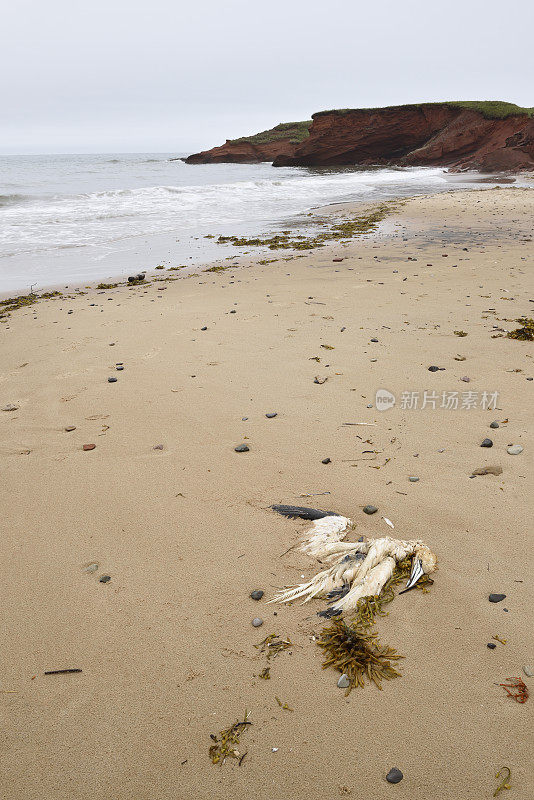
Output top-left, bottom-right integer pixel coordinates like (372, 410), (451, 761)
(0, 189), (534, 800)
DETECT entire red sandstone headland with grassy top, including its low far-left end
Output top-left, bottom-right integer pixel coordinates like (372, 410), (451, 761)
(184, 102), (534, 172)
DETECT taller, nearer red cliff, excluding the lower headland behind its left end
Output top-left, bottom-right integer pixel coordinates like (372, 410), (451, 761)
(274, 104), (534, 172)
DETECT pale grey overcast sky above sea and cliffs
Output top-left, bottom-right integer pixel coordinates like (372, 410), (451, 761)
(0, 0), (534, 153)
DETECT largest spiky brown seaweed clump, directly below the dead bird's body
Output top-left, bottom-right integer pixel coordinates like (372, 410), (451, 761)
(317, 617), (404, 696)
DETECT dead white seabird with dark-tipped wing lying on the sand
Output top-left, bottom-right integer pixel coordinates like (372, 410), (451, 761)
(270, 506), (437, 617)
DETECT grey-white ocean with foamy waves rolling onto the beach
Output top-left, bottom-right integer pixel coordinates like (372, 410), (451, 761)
(0, 153), (510, 293)
